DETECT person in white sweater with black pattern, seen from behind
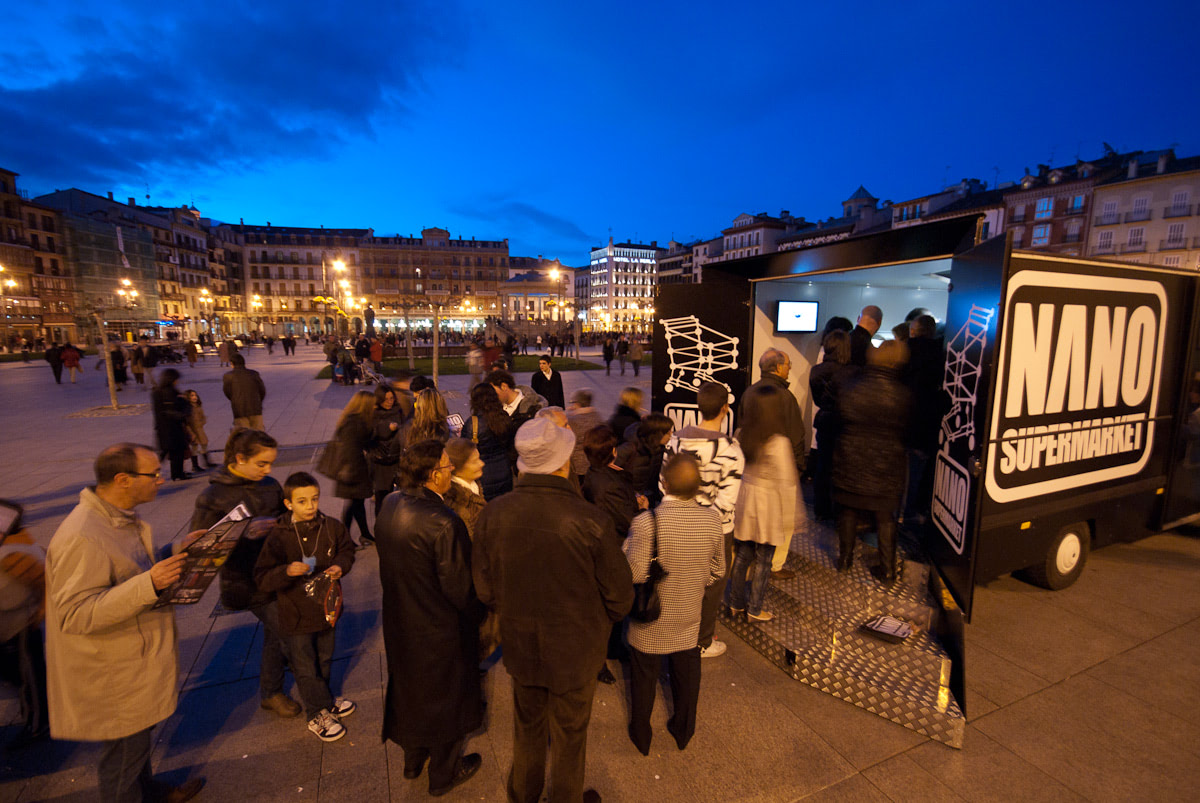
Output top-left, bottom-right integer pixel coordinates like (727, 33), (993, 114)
(659, 382), (746, 658)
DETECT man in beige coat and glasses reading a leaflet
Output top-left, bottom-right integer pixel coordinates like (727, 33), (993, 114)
(46, 443), (204, 803)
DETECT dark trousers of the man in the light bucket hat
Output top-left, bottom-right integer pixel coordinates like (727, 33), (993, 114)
(509, 677), (596, 803)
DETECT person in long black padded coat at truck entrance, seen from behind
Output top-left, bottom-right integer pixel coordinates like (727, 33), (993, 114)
(833, 341), (911, 585)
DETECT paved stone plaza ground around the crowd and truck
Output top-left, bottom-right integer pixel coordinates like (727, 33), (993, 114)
(0, 346), (1200, 803)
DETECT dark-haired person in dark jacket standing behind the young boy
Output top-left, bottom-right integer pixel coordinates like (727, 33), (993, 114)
(191, 427), (302, 718)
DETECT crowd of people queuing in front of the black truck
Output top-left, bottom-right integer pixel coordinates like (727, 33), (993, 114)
(0, 307), (955, 803)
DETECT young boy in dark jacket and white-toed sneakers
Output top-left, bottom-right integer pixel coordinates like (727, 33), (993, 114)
(254, 472), (355, 742)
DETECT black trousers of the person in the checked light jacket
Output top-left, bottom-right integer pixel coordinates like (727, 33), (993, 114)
(629, 647), (700, 755)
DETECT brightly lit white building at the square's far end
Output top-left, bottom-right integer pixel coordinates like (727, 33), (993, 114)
(578, 238), (667, 332)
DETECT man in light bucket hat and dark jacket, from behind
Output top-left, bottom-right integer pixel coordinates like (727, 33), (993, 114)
(473, 419), (634, 803)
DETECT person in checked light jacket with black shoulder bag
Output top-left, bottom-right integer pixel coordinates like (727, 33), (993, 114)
(624, 454), (725, 756)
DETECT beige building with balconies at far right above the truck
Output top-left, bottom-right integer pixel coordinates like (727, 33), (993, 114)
(1087, 150), (1200, 270)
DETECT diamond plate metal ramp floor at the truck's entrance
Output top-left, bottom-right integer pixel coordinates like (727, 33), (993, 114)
(721, 520), (966, 748)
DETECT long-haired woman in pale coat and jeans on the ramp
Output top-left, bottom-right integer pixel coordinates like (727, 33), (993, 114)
(725, 385), (799, 622)
